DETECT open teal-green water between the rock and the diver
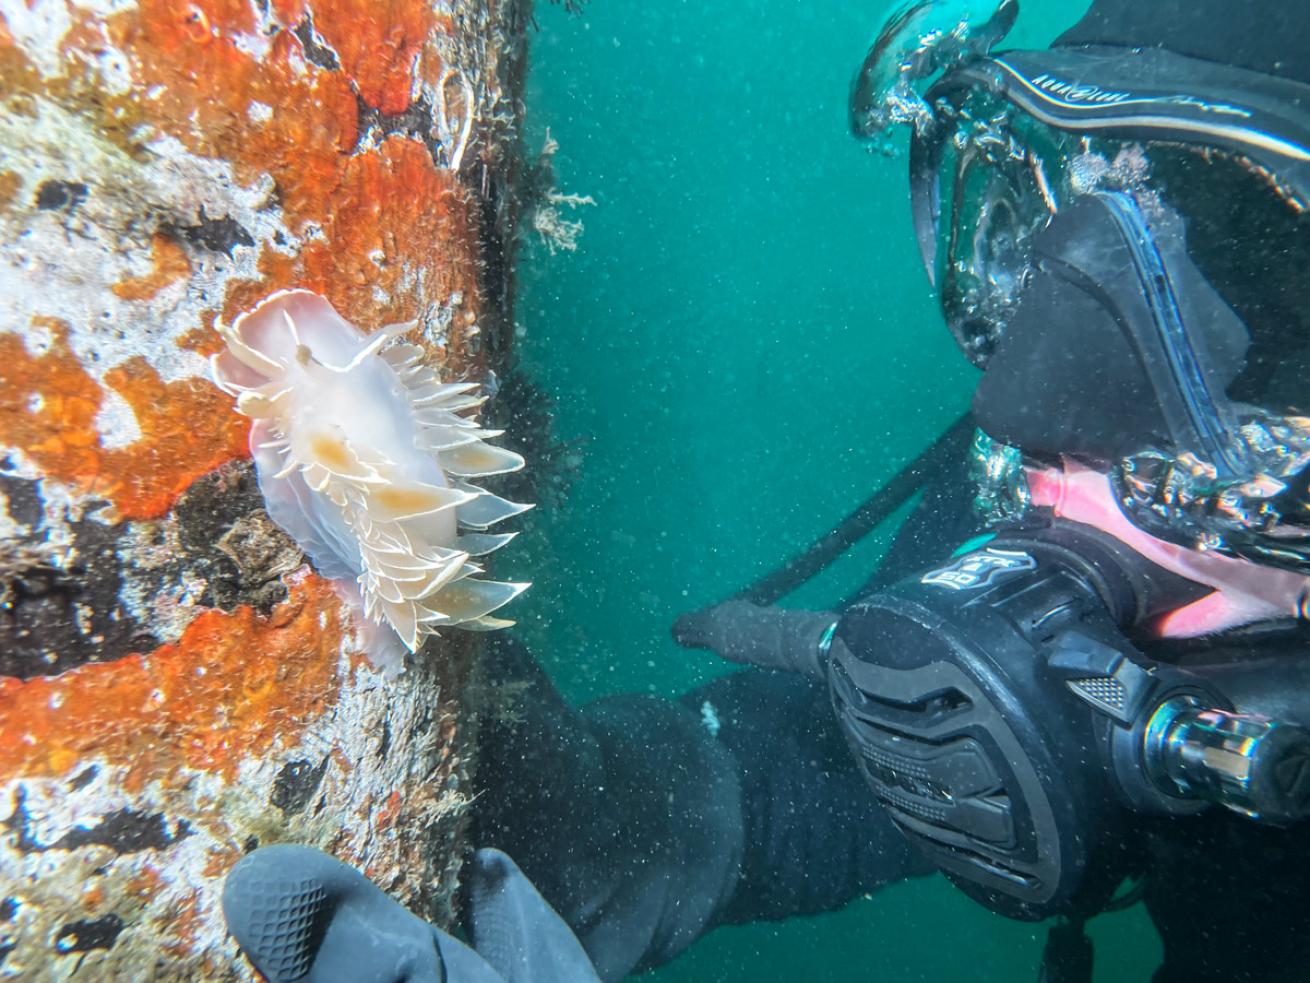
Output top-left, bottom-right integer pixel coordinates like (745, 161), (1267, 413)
(506, 0), (1159, 983)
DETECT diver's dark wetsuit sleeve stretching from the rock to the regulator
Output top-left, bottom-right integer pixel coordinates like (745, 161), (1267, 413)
(470, 638), (926, 980)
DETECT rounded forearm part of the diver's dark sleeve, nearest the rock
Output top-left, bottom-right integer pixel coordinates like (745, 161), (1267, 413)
(469, 636), (741, 980)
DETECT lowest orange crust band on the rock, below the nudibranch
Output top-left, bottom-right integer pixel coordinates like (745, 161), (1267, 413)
(0, 577), (345, 792)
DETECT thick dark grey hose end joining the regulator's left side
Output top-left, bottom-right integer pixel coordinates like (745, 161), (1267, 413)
(673, 600), (837, 679)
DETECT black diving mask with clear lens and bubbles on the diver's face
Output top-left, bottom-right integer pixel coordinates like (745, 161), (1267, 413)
(853, 3), (1310, 573)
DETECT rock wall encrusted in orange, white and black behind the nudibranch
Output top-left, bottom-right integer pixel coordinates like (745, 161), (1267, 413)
(0, 0), (527, 980)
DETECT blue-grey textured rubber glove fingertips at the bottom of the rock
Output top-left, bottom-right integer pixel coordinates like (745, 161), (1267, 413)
(223, 844), (599, 983)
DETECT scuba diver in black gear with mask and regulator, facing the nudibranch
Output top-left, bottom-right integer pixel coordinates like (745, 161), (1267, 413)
(223, 0), (1310, 983)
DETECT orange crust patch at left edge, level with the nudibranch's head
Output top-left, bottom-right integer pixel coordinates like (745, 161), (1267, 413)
(0, 321), (248, 519)
